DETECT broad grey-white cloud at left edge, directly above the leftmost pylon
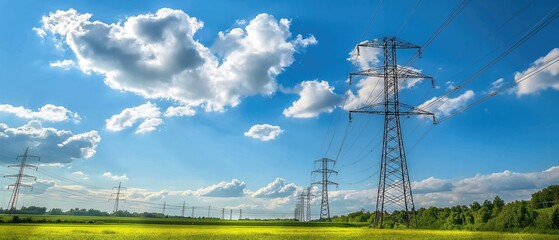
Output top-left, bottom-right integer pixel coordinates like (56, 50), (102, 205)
(0, 120), (101, 163)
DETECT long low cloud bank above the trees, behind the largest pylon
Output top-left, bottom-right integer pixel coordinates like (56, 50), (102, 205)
(329, 166), (559, 213)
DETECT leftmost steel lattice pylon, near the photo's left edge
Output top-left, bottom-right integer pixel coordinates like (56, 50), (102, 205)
(4, 148), (41, 215)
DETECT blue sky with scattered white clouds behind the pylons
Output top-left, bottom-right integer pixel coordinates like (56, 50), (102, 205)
(0, 0), (559, 217)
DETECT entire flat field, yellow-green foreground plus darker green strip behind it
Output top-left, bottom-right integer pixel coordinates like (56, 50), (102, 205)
(0, 215), (559, 240)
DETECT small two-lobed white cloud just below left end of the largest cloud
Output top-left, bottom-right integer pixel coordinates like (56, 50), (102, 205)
(105, 102), (163, 134)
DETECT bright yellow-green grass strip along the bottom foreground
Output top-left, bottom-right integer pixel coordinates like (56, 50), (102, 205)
(0, 223), (559, 240)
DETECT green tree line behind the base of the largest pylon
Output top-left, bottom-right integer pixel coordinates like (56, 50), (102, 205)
(332, 185), (559, 232)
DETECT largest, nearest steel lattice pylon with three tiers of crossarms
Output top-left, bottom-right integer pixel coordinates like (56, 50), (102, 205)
(349, 37), (435, 228)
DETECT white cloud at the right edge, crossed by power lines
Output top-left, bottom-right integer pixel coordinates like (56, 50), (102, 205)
(514, 48), (559, 96)
